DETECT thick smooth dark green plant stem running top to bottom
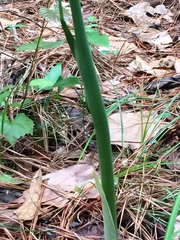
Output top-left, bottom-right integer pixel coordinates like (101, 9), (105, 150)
(70, 0), (117, 234)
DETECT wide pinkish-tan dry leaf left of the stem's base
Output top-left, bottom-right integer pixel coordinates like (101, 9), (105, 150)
(42, 164), (99, 208)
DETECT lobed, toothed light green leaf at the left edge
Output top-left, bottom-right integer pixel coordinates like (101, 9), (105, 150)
(0, 113), (34, 146)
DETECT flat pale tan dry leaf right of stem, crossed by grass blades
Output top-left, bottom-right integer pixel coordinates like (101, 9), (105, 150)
(108, 111), (165, 149)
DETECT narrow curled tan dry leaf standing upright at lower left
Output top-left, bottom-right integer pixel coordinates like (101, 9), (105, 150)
(15, 169), (42, 221)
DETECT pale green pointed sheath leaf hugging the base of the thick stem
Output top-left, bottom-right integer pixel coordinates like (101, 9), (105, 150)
(93, 172), (117, 240)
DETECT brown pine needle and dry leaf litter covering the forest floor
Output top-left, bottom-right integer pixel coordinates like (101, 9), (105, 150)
(0, 0), (180, 240)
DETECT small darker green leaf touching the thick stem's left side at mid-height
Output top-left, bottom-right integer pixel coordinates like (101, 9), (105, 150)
(54, 77), (81, 92)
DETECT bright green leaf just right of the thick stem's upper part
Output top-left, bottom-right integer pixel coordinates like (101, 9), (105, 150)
(87, 29), (109, 47)
